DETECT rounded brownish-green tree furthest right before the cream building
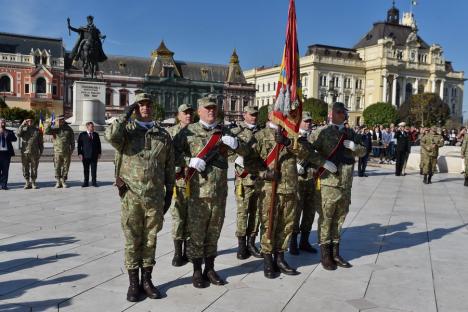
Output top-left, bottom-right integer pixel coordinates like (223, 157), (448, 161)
(399, 93), (450, 127)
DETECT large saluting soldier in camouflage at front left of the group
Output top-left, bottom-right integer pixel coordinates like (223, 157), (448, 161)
(105, 93), (175, 302)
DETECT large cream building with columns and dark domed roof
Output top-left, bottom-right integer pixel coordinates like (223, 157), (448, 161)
(244, 6), (465, 124)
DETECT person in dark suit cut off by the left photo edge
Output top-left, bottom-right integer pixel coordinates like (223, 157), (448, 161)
(0, 119), (17, 190)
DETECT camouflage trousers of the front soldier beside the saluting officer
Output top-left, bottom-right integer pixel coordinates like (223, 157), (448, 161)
(187, 195), (226, 259)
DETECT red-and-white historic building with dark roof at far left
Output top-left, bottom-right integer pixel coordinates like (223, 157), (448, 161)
(0, 33), (64, 114)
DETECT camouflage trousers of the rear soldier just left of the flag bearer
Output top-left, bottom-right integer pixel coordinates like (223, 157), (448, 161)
(235, 178), (260, 237)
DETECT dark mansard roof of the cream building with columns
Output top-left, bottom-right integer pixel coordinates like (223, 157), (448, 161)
(353, 22), (429, 49)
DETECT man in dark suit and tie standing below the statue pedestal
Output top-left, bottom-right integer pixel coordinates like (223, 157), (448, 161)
(78, 122), (101, 187)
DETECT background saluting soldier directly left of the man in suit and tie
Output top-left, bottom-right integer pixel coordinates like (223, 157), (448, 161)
(45, 116), (75, 188)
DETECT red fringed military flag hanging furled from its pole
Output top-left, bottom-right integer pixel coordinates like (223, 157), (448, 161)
(272, 0), (302, 135)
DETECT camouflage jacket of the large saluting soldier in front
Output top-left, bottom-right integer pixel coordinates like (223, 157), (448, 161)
(105, 116), (175, 202)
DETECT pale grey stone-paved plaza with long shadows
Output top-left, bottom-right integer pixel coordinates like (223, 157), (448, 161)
(0, 162), (468, 312)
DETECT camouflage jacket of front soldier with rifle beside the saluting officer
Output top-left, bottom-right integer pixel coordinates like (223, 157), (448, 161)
(174, 122), (248, 198)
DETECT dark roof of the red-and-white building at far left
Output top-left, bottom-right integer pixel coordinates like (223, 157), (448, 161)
(0, 32), (64, 58)
